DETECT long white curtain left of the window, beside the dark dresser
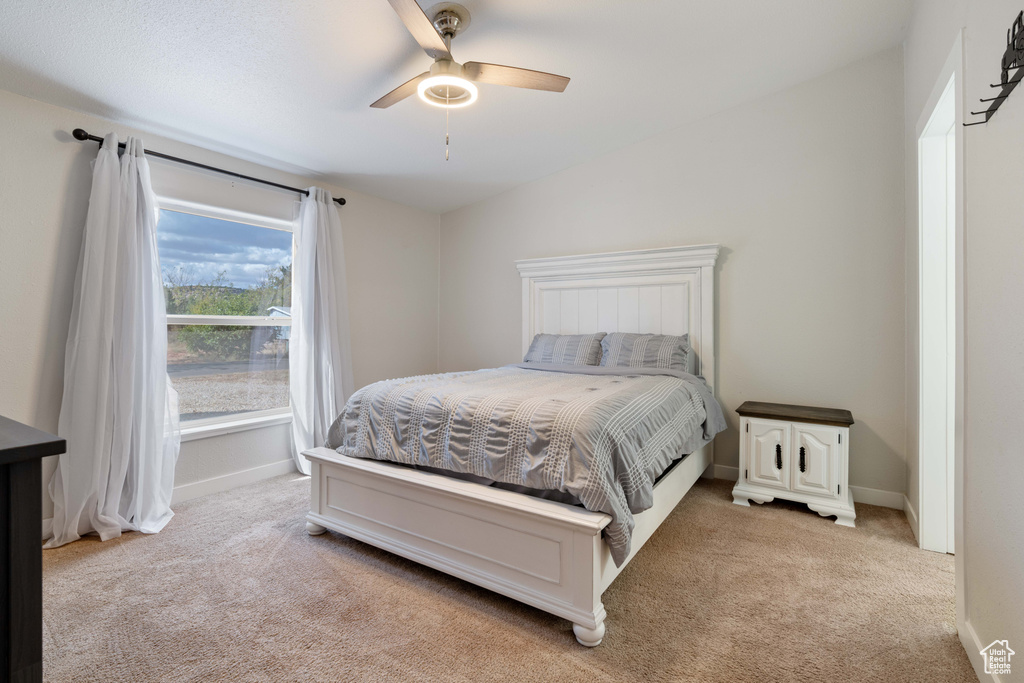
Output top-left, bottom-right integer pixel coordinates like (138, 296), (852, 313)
(45, 133), (180, 548)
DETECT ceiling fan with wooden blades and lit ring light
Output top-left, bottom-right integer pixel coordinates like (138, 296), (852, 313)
(371, 0), (569, 109)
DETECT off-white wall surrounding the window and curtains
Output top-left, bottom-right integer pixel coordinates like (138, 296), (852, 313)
(0, 91), (438, 517)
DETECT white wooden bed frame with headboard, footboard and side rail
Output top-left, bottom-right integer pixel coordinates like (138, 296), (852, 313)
(304, 245), (719, 647)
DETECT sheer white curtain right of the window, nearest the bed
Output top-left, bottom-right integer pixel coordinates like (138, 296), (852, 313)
(289, 187), (352, 474)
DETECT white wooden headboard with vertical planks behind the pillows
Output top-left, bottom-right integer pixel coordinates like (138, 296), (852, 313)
(516, 245), (719, 389)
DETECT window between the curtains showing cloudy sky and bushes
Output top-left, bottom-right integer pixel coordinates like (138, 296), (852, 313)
(157, 200), (292, 427)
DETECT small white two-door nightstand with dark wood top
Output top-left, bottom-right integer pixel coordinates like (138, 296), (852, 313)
(732, 400), (857, 526)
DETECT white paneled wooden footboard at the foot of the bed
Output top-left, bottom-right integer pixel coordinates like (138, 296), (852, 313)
(304, 449), (611, 646)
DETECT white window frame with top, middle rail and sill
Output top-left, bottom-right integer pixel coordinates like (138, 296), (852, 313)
(156, 195), (295, 441)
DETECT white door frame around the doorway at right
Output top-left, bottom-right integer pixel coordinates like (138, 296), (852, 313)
(915, 31), (966, 634)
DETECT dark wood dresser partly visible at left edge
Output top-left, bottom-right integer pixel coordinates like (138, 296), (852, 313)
(0, 417), (65, 683)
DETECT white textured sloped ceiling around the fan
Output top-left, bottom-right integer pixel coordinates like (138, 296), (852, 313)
(0, 0), (911, 212)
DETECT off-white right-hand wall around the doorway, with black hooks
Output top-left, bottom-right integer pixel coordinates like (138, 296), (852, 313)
(905, 0), (1024, 676)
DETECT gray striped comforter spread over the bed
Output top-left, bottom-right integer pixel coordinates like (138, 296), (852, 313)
(327, 364), (725, 565)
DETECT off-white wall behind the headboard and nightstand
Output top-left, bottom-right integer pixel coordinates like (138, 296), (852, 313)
(439, 49), (906, 500)
